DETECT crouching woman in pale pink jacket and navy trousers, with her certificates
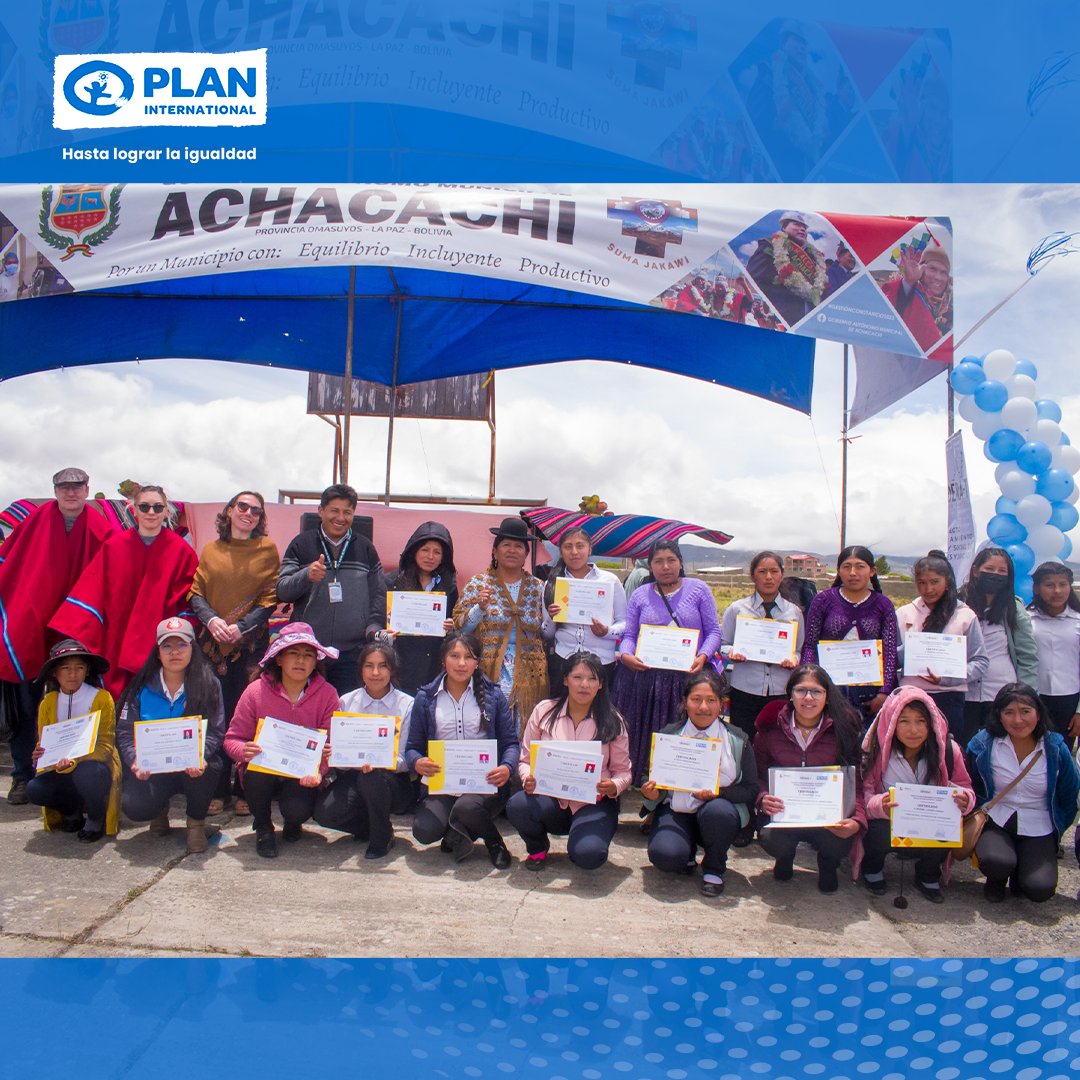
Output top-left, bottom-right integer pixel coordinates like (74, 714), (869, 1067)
(507, 652), (631, 870)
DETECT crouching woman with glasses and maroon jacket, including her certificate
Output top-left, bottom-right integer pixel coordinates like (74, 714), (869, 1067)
(754, 664), (866, 892)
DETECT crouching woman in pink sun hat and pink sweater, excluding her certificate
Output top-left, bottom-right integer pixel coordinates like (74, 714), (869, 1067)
(225, 622), (338, 859)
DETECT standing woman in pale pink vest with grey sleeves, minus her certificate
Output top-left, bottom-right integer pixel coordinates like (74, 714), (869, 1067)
(896, 551), (989, 740)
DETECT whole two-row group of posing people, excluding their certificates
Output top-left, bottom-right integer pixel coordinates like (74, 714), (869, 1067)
(0, 469), (1080, 903)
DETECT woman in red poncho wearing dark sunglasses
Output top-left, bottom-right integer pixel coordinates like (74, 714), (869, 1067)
(49, 484), (199, 701)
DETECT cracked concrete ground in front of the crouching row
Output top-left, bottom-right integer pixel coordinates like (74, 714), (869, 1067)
(0, 747), (1080, 957)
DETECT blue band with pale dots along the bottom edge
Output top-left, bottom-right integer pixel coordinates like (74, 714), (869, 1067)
(0, 959), (1080, 1080)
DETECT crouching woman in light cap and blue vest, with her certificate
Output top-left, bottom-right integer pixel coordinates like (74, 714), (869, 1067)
(117, 618), (226, 853)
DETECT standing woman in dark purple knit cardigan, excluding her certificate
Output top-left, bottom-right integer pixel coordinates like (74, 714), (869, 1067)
(802, 544), (900, 727)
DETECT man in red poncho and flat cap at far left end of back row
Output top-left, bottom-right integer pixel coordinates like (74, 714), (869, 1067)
(0, 469), (113, 806)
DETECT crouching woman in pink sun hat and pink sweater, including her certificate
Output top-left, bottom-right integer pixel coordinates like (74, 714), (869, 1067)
(225, 622), (338, 859)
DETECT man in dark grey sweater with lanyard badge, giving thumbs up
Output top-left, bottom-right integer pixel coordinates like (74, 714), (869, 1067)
(278, 484), (389, 694)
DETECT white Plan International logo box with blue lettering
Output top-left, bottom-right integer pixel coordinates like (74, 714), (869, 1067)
(53, 49), (267, 131)
